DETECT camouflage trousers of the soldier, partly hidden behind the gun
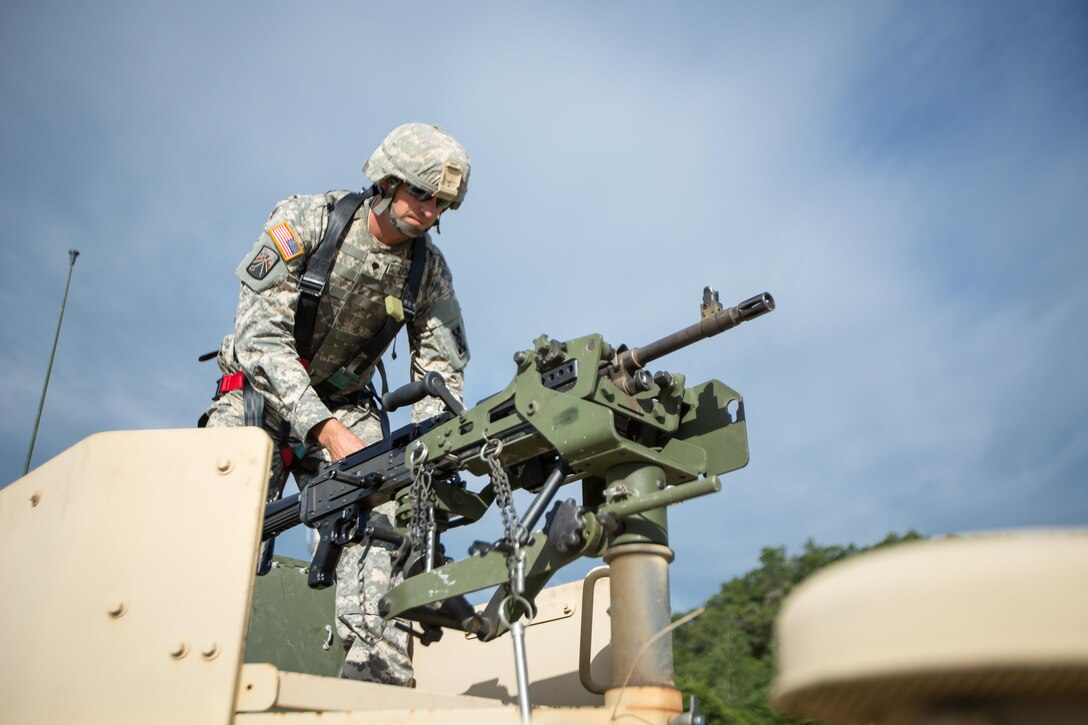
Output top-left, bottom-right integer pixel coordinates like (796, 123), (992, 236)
(208, 391), (412, 685)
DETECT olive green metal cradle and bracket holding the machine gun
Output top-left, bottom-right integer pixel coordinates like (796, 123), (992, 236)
(382, 343), (749, 640)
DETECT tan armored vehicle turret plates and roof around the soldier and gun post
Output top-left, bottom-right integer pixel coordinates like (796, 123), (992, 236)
(0, 428), (681, 725)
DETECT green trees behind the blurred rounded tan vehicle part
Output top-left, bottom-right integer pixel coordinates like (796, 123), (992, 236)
(672, 530), (924, 725)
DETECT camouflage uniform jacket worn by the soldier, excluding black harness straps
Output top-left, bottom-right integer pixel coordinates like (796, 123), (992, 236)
(219, 192), (469, 443)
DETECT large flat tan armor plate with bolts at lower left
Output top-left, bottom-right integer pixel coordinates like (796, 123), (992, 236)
(0, 429), (272, 723)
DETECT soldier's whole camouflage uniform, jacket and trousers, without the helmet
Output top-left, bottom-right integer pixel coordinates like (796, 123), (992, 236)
(208, 192), (469, 685)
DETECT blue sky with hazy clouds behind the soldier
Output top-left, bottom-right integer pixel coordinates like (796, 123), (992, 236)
(0, 1), (1088, 609)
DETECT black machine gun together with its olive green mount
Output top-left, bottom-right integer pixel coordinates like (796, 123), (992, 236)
(262, 287), (775, 640)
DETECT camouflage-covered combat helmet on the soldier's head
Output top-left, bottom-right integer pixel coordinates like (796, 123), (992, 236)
(362, 123), (469, 209)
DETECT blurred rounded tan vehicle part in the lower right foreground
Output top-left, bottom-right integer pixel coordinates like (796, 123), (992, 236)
(772, 531), (1088, 725)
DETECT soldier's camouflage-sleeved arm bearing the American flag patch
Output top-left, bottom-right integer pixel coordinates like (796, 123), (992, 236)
(234, 197), (341, 440)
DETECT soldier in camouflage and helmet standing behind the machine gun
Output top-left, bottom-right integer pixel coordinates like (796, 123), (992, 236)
(207, 123), (469, 685)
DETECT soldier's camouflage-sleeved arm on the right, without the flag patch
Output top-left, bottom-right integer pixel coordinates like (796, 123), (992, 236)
(408, 247), (469, 422)
